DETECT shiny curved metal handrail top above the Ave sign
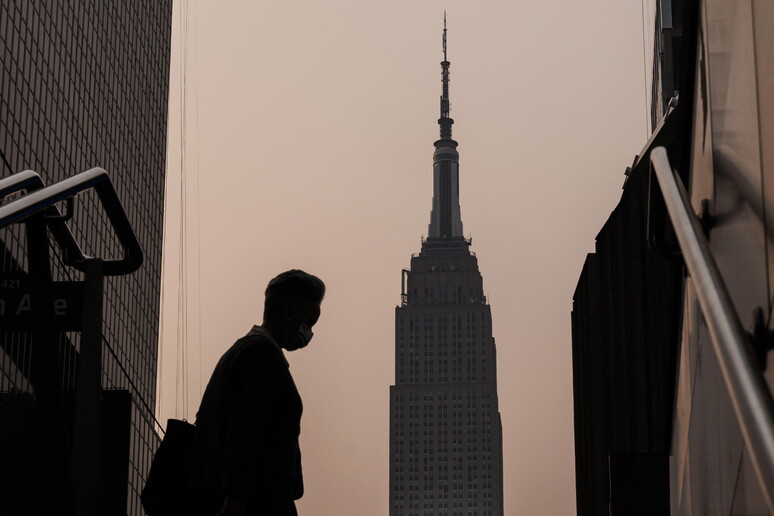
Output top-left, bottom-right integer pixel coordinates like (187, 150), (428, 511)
(0, 168), (143, 276)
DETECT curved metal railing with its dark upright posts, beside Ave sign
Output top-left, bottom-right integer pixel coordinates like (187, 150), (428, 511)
(0, 168), (143, 516)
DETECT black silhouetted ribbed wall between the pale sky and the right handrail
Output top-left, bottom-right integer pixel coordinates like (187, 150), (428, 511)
(572, 160), (682, 515)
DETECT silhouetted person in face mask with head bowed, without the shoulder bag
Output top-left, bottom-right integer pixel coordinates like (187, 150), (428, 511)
(190, 270), (325, 516)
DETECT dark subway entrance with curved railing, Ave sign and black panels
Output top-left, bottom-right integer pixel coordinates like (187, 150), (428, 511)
(0, 168), (143, 516)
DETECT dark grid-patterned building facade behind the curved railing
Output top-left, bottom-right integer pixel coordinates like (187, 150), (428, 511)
(0, 0), (172, 515)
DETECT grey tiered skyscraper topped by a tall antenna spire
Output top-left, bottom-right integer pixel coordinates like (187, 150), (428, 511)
(390, 22), (503, 516)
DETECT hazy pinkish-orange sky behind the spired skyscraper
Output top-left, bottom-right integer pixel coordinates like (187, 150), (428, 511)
(159, 0), (650, 516)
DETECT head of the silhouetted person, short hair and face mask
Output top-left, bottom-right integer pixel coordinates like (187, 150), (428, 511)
(263, 269), (325, 351)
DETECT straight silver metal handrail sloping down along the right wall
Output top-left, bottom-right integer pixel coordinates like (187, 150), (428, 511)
(650, 147), (774, 514)
